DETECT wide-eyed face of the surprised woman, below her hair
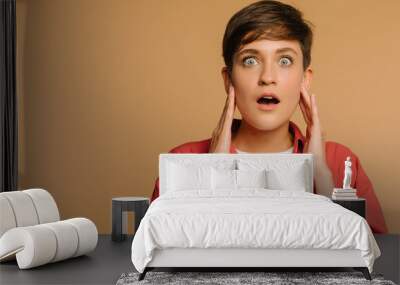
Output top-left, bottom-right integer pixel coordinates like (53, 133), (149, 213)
(232, 39), (304, 130)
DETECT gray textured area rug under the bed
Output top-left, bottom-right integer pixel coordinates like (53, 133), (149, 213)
(116, 271), (395, 285)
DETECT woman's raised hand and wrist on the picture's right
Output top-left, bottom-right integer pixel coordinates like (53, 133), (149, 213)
(299, 84), (334, 197)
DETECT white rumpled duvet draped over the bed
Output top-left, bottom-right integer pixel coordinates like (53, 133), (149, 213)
(132, 188), (381, 272)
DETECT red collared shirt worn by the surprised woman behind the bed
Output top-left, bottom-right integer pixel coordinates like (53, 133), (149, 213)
(150, 119), (388, 233)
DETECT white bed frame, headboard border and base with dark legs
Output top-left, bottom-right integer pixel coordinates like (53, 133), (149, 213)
(139, 153), (371, 280)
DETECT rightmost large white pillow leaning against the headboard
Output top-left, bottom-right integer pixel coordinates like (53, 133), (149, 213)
(267, 163), (308, 192)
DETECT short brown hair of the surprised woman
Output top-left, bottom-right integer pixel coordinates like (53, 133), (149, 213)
(222, 0), (313, 75)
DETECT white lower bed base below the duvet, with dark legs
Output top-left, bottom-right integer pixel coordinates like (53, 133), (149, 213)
(138, 248), (371, 281)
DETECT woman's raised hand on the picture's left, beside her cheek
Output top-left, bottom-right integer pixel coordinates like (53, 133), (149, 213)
(208, 84), (236, 153)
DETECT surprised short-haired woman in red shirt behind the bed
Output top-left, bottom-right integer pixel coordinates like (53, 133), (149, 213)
(151, 0), (387, 233)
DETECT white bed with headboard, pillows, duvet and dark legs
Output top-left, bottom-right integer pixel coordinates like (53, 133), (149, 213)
(131, 153), (381, 280)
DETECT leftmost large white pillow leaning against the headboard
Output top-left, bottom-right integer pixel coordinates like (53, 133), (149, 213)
(167, 162), (211, 191)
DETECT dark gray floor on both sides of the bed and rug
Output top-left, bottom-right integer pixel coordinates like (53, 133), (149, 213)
(0, 234), (400, 285)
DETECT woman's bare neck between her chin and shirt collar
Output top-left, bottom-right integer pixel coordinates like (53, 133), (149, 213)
(232, 119), (293, 152)
